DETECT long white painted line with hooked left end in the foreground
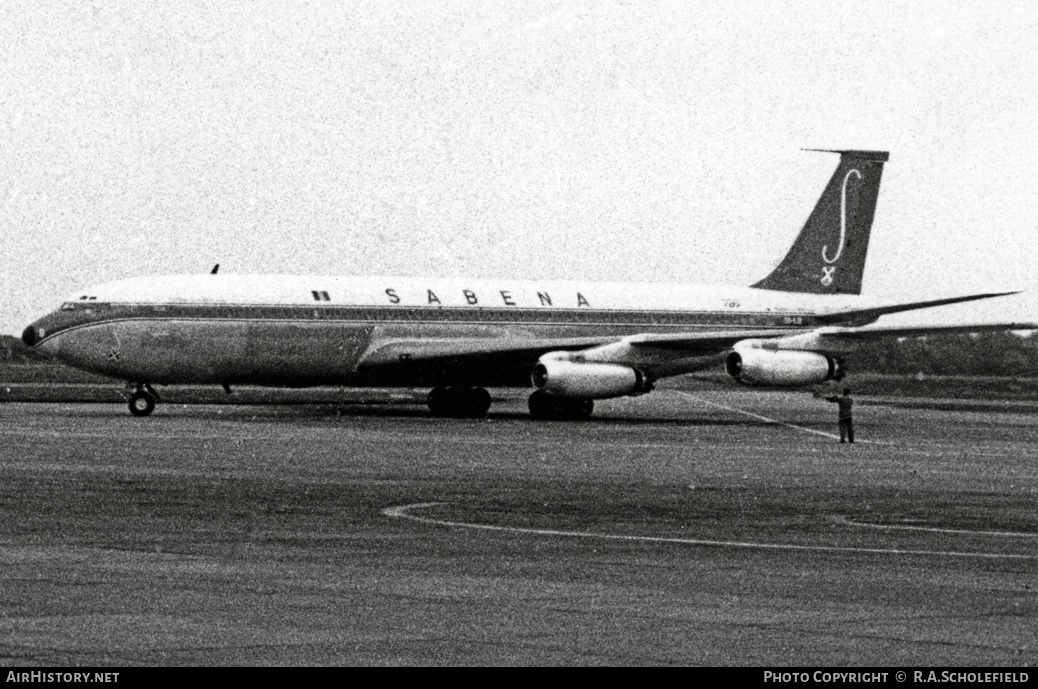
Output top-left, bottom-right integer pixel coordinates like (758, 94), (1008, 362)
(382, 502), (1038, 560)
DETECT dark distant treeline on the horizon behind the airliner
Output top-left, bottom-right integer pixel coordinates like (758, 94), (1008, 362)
(0, 332), (1038, 376)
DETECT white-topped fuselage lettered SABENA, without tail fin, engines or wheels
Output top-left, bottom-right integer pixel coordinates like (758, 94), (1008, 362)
(26, 275), (861, 387)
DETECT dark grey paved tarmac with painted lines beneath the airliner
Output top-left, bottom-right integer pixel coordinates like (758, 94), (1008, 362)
(0, 390), (1038, 666)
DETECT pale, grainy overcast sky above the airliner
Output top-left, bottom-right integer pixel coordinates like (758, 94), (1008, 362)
(0, 0), (1038, 333)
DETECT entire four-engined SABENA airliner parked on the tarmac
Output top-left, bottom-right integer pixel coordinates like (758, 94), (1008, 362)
(23, 150), (1036, 418)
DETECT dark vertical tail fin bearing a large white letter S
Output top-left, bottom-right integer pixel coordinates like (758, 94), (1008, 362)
(753, 150), (890, 295)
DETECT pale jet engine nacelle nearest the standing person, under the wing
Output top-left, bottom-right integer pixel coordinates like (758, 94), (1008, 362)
(725, 349), (844, 386)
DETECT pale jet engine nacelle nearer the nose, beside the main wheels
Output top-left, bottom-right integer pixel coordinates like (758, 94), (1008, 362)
(530, 358), (652, 399)
